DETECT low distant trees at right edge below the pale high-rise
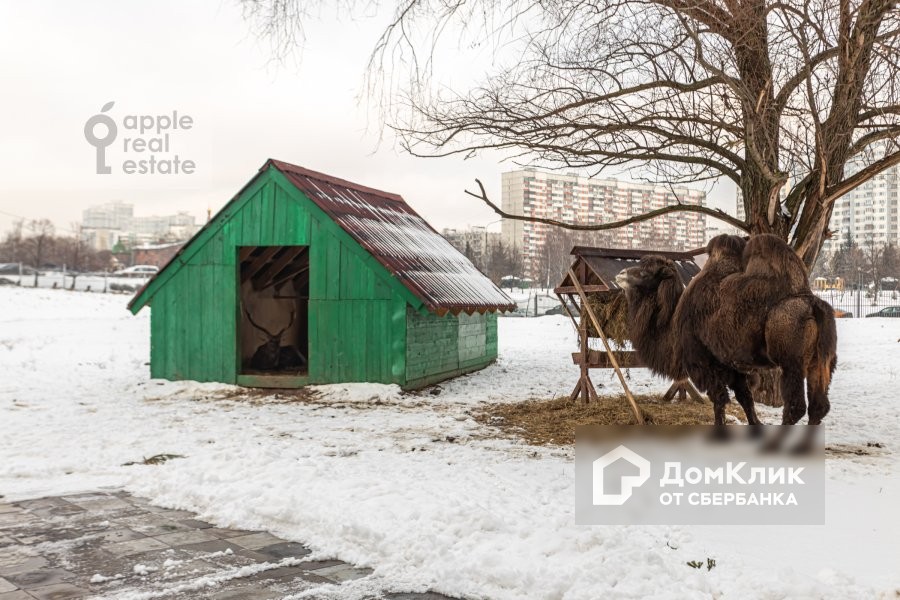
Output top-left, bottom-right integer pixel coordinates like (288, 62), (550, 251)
(812, 237), (900, 288)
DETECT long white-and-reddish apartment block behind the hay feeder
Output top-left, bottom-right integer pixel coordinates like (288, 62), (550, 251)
(502, 169), (706, 276)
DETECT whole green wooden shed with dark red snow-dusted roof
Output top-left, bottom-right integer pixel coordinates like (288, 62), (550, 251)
(128, 160), (515, 389)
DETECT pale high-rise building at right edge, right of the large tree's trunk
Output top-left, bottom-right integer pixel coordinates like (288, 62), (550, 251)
(822, 165), (900, 253)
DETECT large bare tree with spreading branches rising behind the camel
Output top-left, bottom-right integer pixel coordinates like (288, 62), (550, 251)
(245, 0), (900, 268)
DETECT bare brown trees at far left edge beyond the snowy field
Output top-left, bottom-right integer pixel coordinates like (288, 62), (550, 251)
(0, 219), (112, 285)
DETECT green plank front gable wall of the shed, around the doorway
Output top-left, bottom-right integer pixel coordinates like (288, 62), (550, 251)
(151, 175), (406, 385)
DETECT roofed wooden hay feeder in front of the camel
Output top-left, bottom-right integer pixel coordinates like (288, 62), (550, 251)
(553, 246), (703, 423)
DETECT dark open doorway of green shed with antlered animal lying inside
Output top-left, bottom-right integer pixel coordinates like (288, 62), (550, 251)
(237, 246), (309, 376)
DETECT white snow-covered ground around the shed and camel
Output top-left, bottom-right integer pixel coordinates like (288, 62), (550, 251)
(0, 287), (900, 599)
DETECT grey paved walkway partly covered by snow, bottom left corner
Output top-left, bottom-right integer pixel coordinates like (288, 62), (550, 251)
(0, 492), (447, 600)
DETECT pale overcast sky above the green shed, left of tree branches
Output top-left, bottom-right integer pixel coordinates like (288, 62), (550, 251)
(0, 0), (734, 238)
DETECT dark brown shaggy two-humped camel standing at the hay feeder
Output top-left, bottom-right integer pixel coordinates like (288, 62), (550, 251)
(617, 235), (837, 425)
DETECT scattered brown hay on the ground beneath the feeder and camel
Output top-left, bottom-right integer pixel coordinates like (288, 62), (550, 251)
(474, 394), (744, 446)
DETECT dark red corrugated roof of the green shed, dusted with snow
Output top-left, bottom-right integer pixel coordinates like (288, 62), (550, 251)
(262, 160), (515, 314)
